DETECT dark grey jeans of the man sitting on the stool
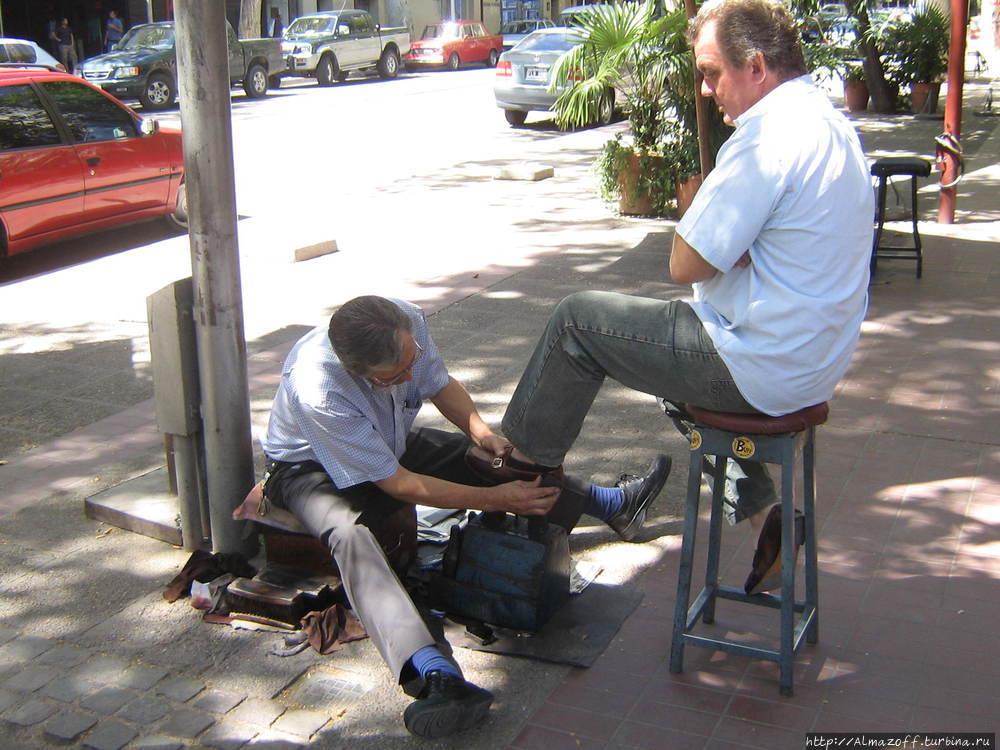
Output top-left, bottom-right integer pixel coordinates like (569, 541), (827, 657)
(502, 291), (776, 518)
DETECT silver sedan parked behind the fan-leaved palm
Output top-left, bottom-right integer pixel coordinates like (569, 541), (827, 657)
(493, 26), (615, 127)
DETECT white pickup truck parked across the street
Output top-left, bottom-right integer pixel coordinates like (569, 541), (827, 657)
(281, 9), (410, 86)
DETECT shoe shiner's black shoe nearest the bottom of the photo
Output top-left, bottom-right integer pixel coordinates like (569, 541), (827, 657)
(403, 671), (493, 740)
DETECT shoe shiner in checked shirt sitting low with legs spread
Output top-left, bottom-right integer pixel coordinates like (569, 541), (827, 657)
(263, 296), (670, 737)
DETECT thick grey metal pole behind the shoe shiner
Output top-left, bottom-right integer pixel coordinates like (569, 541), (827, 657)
(174, 0), (253, 552)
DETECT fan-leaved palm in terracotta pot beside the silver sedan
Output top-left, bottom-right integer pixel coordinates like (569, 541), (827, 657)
(553, 0), (724, 216)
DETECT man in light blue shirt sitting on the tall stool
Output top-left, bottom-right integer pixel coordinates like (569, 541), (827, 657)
(502, 0), (874, 593)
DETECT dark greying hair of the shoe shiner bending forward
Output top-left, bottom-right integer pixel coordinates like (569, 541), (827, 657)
(328, 295), (413, 376)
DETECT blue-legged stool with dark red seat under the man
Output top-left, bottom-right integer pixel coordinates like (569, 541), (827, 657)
(668, 403), (829, 696)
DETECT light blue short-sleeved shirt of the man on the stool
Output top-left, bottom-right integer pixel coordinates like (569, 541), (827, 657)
(677, 76), (875, 415)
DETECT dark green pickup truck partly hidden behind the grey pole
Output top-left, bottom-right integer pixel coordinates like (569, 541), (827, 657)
(77, 21), (285, 110)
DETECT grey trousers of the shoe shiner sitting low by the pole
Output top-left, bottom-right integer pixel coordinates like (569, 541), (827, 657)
(264, 428), (589, 683)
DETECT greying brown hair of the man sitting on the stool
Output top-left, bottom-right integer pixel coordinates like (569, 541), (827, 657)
(688, 0), (809, 81)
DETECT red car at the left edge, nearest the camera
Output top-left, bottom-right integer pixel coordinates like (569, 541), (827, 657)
(0, 68), (187, 256)
